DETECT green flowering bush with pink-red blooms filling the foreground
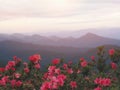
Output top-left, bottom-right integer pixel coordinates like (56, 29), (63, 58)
(0, 47), (120, 90)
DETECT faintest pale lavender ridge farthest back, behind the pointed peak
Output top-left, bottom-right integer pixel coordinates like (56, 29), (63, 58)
(41, 27), (120, 39)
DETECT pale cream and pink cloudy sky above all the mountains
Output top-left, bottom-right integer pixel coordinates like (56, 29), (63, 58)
(0, 0), (120, 33)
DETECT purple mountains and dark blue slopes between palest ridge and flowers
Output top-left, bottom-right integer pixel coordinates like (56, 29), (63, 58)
(0, 33), (120, 66)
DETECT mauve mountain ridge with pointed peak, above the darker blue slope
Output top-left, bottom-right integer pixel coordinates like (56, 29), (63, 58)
(0, 33), (120, 48)
